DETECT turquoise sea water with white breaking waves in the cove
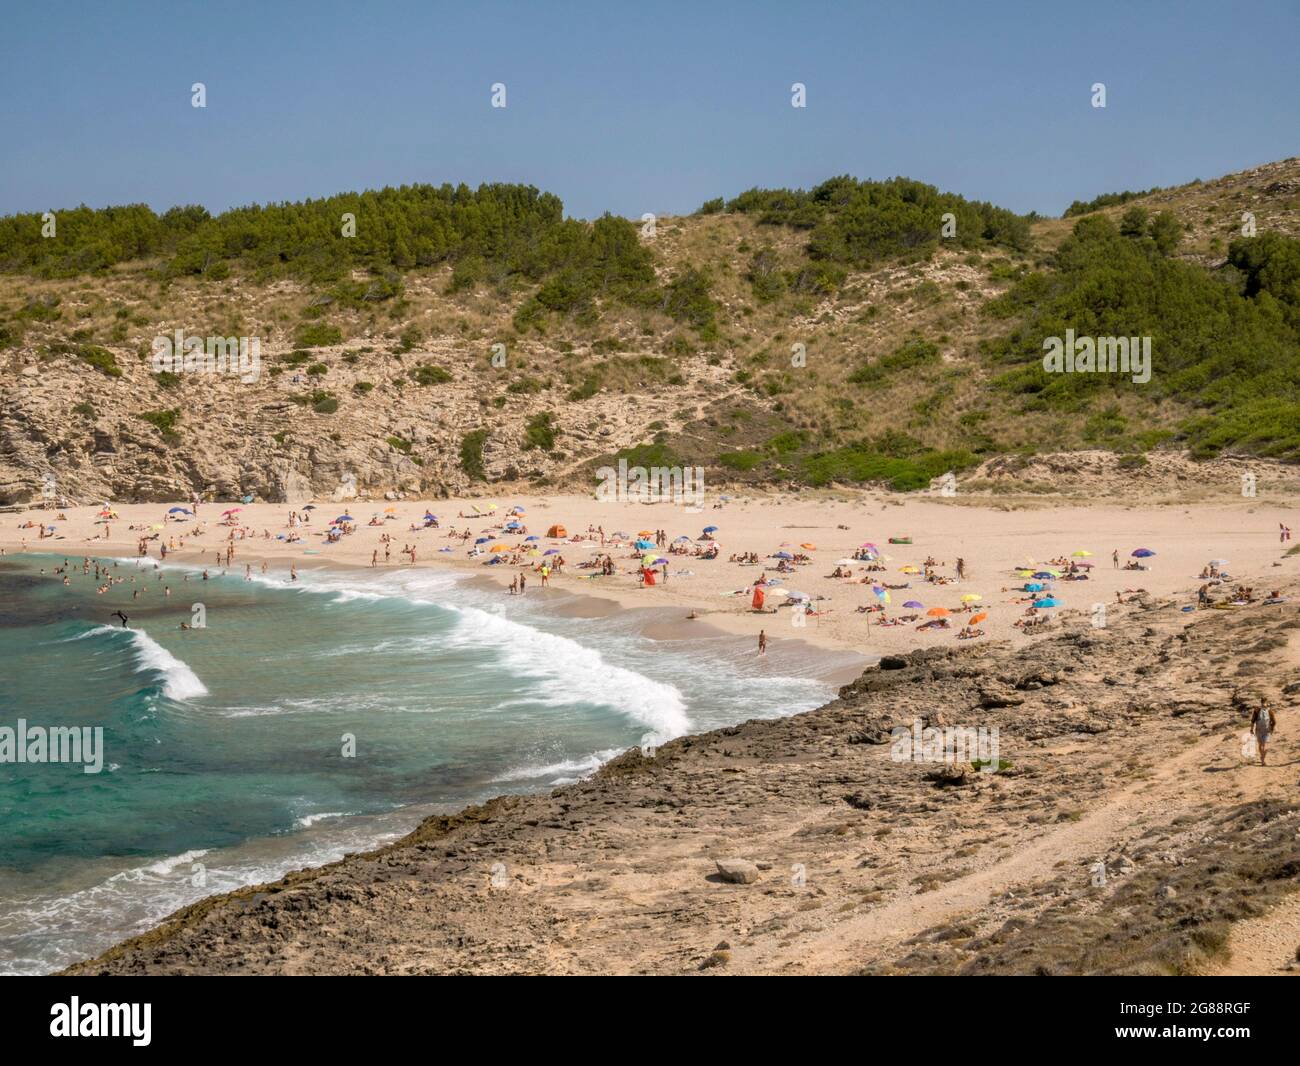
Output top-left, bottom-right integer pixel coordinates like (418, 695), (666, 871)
(0, 555), (853, 972)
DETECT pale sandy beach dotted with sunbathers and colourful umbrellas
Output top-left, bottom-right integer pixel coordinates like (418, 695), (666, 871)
(0, 493), (1300, 657)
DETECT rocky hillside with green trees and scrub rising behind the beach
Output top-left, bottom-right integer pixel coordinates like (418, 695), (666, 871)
(0, 160), (1300, 498)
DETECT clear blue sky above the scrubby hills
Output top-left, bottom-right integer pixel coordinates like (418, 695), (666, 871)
(0, 0), (1300, 217)
